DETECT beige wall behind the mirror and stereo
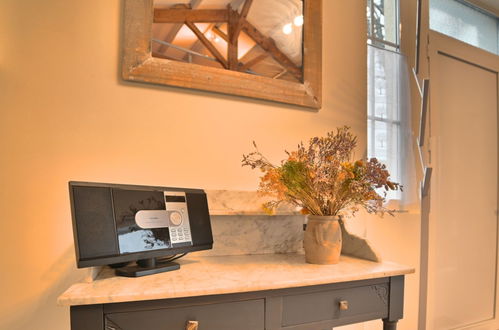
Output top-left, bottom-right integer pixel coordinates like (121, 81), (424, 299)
(0, 0), (366, 330)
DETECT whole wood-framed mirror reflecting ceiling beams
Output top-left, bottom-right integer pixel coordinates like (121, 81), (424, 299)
(122, 0), (322, 109)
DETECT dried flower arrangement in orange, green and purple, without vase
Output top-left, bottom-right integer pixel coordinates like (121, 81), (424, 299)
(242, 126), (402, 216)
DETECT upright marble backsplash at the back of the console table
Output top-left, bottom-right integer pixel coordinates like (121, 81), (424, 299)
(201, 190), (381, 262)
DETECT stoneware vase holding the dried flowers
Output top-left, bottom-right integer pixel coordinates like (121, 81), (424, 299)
(303, 215), (341, 265)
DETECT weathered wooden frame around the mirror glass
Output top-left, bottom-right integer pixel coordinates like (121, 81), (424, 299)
(122, 0), (322, 109)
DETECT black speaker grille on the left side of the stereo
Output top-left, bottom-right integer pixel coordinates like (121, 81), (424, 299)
(73, 186), (119, 259)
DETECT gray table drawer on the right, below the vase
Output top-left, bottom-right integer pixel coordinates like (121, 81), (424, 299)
(282, 283), (389, 327)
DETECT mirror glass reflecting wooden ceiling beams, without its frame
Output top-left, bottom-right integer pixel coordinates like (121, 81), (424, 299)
(152, 0), (304, 83)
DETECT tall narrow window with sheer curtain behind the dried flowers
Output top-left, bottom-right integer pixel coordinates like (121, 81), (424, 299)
(367, 0), (407, 200)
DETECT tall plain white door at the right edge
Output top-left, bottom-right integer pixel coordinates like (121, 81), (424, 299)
(426, 32), (499, 330)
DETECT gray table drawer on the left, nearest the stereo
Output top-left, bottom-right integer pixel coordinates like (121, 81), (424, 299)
(105, 299), (265, 330)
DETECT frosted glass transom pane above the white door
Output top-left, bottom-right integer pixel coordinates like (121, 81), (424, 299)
(430, 0), (499, 54)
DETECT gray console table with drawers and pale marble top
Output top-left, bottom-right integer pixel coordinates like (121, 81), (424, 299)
(59, 255), (414, 330)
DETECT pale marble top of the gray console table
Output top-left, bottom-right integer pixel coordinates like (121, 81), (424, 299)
(58, 254), (414, 306)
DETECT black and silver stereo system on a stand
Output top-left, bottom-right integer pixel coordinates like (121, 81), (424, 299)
(69, 181), (213, 276)
